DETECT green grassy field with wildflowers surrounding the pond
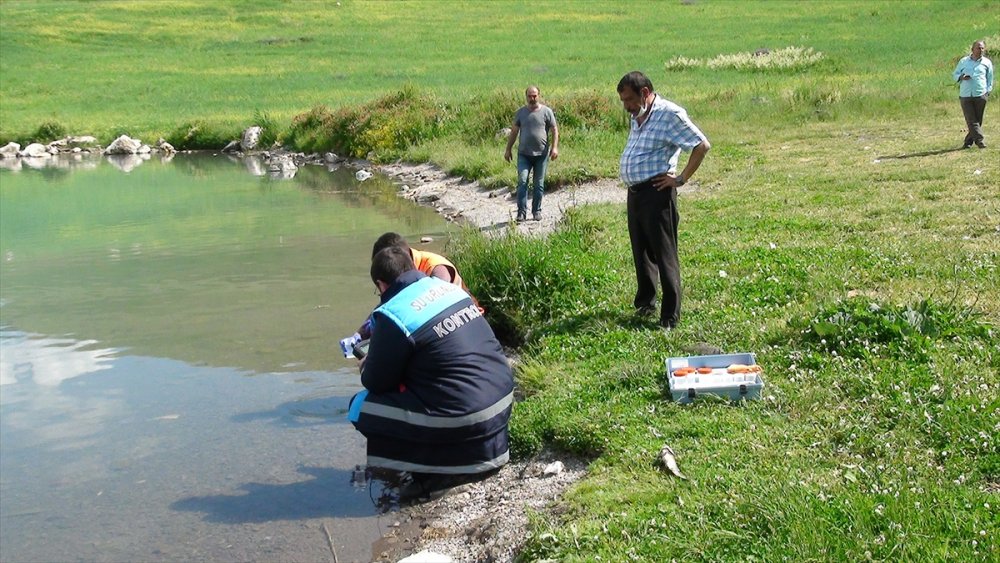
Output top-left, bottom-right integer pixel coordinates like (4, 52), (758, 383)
(0, 0), (1000, 561)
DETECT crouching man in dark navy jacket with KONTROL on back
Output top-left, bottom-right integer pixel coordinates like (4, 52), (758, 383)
(348, 247), (514, 502)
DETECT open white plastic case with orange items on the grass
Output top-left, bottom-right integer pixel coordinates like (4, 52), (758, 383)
(666, 353), (764, 403)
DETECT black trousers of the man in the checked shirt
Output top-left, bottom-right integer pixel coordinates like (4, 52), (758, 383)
(626, 182), (681, 327)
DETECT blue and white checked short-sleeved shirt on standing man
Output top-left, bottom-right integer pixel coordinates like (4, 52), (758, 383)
(621, 94), (708, 186)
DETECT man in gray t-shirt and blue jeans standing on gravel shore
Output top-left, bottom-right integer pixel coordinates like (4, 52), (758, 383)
(503, 86), (559, 221)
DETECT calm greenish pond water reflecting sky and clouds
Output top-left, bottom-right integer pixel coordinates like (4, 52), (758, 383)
(0, 155), (458, 562)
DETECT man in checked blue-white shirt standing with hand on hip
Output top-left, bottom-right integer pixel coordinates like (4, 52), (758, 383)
(618, 71), (712, 331)
